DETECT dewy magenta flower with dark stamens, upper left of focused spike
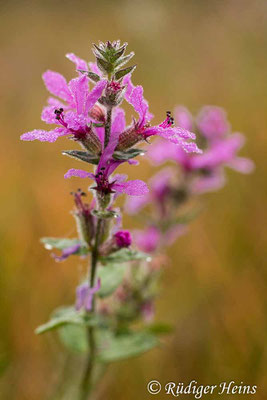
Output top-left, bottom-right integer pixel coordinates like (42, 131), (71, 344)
(21, 71), (107, 142)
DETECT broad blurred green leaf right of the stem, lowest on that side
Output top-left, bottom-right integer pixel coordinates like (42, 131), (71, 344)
(97, 331), (159, 362)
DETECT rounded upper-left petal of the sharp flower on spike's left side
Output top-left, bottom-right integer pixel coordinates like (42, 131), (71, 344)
(43, 70), (72, 102)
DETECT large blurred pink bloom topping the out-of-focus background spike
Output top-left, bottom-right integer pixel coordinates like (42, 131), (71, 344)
(148, 106), (254, 193)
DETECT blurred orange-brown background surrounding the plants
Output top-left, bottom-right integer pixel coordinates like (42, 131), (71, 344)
(0, 0), (267, 400)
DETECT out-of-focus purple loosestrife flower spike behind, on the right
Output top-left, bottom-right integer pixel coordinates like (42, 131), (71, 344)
(126, 106), (254, 253)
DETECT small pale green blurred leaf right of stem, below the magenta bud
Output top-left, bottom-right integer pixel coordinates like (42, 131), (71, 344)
(97, 264), (126, 297)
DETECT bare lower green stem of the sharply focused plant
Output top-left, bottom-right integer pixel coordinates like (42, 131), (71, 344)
(80, 219), (102, 400)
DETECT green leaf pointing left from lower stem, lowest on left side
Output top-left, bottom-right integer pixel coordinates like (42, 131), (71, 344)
(35, 307), (96, 335)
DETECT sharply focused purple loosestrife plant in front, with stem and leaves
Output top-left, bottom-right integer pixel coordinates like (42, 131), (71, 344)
(21, 41), (201, 400)
